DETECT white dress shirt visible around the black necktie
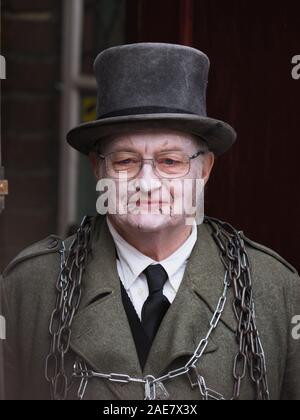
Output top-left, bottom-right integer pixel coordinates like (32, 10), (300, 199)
(106, 217), (198, 319)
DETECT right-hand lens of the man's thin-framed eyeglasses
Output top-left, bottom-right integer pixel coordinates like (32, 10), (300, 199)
(156, 152), (190, 177)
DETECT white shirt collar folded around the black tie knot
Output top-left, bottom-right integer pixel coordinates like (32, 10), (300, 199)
(106, 217), (198, 292)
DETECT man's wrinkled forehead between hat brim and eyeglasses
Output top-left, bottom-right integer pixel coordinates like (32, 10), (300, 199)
(98, 129), (200, 153)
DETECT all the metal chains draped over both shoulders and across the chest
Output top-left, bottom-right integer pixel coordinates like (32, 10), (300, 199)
(46, 217), (269, 400)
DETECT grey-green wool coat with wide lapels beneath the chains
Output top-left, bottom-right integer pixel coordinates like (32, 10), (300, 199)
(1, 217), (300, 400)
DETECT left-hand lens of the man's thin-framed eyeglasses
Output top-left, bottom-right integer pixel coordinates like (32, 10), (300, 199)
(108, 152), (141, 178)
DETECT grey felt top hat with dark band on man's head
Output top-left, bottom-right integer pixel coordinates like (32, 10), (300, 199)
(67, 43), (236, 155)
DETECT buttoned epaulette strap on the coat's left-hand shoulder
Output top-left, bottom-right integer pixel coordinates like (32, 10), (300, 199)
(3, 235), (62, 277)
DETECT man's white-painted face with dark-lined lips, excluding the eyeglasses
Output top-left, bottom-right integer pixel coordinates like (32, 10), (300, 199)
(90, 130), (214, 232)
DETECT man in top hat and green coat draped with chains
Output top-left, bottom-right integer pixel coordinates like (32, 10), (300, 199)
(2, 44), (300, 400)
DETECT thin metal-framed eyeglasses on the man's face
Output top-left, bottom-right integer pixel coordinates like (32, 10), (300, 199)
(98, 151), (206, 180)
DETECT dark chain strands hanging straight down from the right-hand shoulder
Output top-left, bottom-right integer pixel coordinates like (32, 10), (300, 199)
(206, 218), (270, 400)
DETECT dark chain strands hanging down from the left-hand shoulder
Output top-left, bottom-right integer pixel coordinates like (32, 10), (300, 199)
(45, 217), (91, 400)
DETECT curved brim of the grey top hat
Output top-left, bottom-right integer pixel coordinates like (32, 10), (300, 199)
(67, 114), (236, 156)
